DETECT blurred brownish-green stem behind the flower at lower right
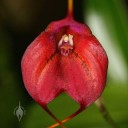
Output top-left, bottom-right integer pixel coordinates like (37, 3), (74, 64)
(95, 97), (118, 128)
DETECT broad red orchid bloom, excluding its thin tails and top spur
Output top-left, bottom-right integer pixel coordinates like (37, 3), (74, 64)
(22, 0), (108, 127)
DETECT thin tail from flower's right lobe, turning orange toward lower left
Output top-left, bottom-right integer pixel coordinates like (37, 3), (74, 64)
(48, 106), (84, 128)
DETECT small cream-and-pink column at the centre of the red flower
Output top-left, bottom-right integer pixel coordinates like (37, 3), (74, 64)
(58, 34), (73, 56)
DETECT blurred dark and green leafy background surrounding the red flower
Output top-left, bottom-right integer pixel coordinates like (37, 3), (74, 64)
(0, 0), (128, 128)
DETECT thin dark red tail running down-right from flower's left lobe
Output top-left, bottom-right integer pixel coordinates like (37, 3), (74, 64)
(43, 106), (66, 128)
